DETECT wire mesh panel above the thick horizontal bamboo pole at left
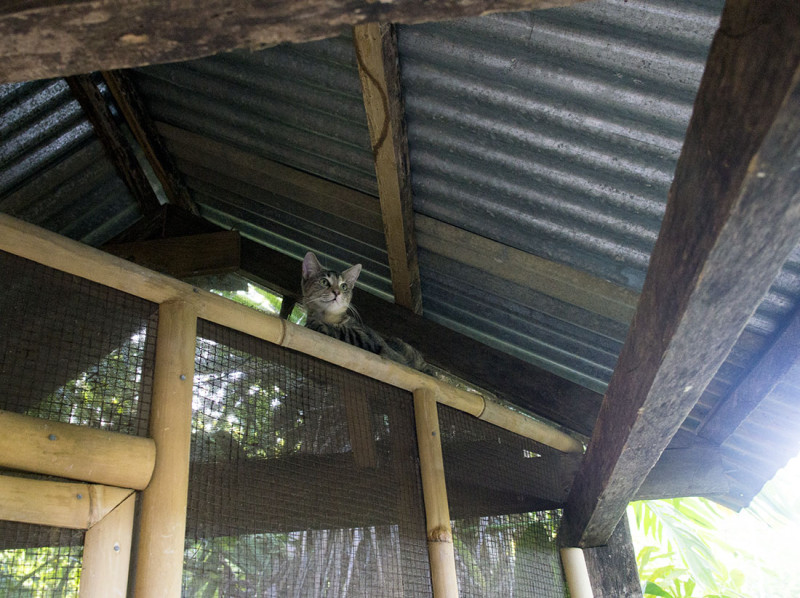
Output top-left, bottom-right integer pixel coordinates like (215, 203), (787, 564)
(0, 252), (158, 436)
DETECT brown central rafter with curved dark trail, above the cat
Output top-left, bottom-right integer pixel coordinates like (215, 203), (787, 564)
(353, 23), (422, 314)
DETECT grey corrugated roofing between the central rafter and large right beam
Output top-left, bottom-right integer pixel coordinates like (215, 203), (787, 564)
(398, 0), (722, 392)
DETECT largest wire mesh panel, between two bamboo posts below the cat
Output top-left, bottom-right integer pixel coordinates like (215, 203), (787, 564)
(184, 321), (431, 598)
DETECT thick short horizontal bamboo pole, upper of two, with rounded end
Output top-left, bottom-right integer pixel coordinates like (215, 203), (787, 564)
(0, 410), (155, 490)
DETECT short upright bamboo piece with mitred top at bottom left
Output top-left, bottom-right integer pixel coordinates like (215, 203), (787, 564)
(78, 493), (136, 598)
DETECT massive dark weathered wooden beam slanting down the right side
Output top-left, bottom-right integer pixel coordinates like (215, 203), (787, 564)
(561, 0), (800, 546)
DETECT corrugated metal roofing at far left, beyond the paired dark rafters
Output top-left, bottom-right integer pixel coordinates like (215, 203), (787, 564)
(0, 79), (141, 245)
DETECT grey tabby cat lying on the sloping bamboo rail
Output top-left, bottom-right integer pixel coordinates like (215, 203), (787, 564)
(303, 251), (432, 373)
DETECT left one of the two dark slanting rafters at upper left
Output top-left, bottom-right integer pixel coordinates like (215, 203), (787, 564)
(66, 75), (161, 215)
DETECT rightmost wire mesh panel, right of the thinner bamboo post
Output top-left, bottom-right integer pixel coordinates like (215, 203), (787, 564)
(439, 405), (577, 598)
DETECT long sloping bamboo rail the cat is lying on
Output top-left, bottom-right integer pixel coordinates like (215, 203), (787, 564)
(0, 215), (583, 452)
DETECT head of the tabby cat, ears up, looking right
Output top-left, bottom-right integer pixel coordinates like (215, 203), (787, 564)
(303, 251), (361, 324)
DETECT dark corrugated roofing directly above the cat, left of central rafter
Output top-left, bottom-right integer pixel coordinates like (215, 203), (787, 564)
(130, 31), (391, 298)
